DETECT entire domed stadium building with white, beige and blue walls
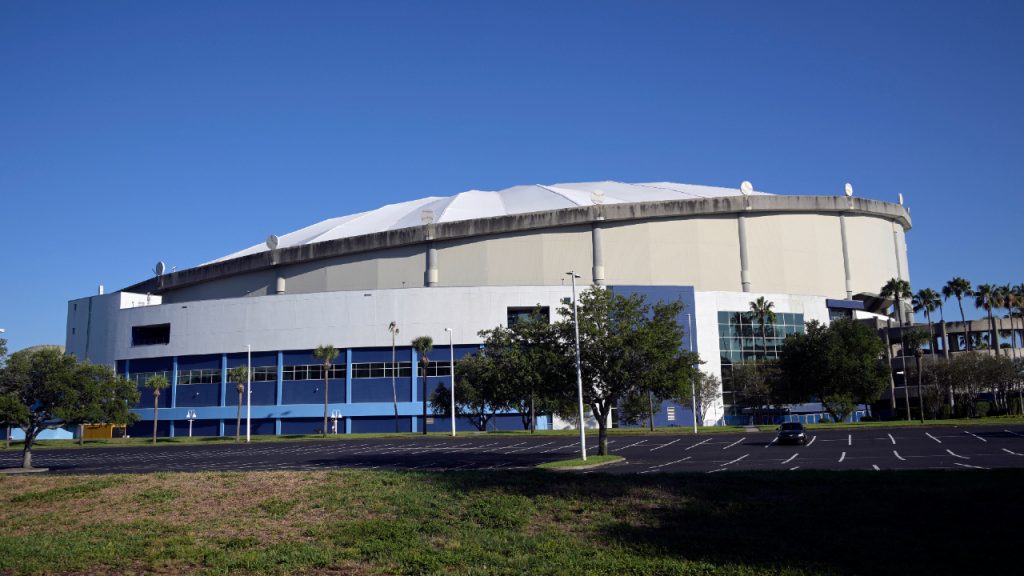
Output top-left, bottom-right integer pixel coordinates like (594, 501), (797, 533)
(67, 181), (910, 436)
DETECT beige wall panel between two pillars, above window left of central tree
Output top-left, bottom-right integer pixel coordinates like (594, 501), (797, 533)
(435, 227), (594, 286)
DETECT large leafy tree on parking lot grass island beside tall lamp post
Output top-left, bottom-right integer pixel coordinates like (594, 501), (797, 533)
(555, 286), (698, 455)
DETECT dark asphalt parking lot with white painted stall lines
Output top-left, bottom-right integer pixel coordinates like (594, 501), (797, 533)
(0, 426), (1024, 475)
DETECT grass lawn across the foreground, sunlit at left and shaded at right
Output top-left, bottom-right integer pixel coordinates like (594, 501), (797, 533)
(0, 469), (1024, 576)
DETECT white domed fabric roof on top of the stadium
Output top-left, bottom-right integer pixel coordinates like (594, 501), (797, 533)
(213, 181), (765, 262)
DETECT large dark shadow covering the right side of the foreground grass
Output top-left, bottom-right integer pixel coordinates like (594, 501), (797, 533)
(407, 470), (1024, 575)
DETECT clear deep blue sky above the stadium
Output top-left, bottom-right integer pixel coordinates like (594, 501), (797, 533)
(0, 0), (1024, 349)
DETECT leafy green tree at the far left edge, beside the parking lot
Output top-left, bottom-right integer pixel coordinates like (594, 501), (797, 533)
(0, 347), (138, 468)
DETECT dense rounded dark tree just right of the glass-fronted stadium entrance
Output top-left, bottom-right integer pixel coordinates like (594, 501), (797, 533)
(779, 319), (889, 421)
